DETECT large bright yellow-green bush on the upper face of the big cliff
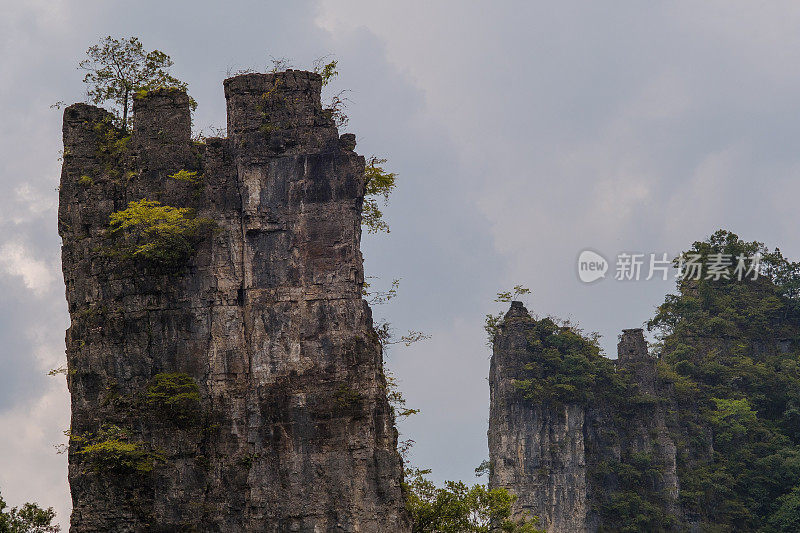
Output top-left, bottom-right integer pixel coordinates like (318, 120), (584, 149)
(109, 199), (214, 269)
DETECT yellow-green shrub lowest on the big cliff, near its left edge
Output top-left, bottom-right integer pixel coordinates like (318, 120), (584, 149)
(70, 425), (158, 474)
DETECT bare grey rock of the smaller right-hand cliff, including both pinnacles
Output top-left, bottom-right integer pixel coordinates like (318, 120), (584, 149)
(488, 302), (680, 533)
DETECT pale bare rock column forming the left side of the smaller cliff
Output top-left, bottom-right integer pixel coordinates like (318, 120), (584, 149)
(488, 302), (589, 532)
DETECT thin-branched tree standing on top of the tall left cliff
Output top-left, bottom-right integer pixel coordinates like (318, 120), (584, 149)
(78, 35), (194, 129)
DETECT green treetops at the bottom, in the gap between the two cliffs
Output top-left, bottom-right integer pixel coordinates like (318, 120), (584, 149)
(404, 470), (541, 533)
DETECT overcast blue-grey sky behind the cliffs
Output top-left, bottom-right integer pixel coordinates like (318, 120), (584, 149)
(0, 0), (800, 523)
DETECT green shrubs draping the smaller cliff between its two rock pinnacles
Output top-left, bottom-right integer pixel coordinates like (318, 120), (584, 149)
(486, 286), (675, 532)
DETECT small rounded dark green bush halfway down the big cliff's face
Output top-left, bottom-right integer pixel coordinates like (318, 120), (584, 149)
(145, 373), (201, 423)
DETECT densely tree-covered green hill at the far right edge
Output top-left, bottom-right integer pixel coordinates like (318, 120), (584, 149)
(649, 231), (800, 532)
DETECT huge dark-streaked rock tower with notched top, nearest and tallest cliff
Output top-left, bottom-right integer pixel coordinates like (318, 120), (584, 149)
(59, 71), (409, 533)
